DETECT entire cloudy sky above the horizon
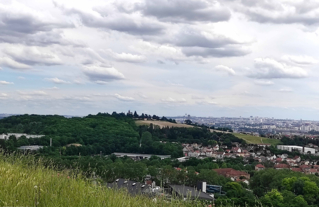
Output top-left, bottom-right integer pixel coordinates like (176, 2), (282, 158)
(0, 0), (319, 120)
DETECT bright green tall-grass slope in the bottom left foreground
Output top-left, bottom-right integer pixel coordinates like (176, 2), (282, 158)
(0, 155), (202, 207)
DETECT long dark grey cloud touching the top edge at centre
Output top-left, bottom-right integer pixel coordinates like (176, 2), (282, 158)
(136, 0), (231, 22)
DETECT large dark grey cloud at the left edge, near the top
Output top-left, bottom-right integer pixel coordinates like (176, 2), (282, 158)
(0, 2), (81, 46)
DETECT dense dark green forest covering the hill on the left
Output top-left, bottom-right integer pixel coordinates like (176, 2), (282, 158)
(0, 112), (244, 158)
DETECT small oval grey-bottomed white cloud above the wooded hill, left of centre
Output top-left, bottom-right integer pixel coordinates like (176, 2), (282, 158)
(83, 66), (125, 83)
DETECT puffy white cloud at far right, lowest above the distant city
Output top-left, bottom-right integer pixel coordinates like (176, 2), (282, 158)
(248, 58), (308, 79)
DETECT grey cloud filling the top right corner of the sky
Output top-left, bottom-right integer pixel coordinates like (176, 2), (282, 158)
(232, 0), (319, 26)
